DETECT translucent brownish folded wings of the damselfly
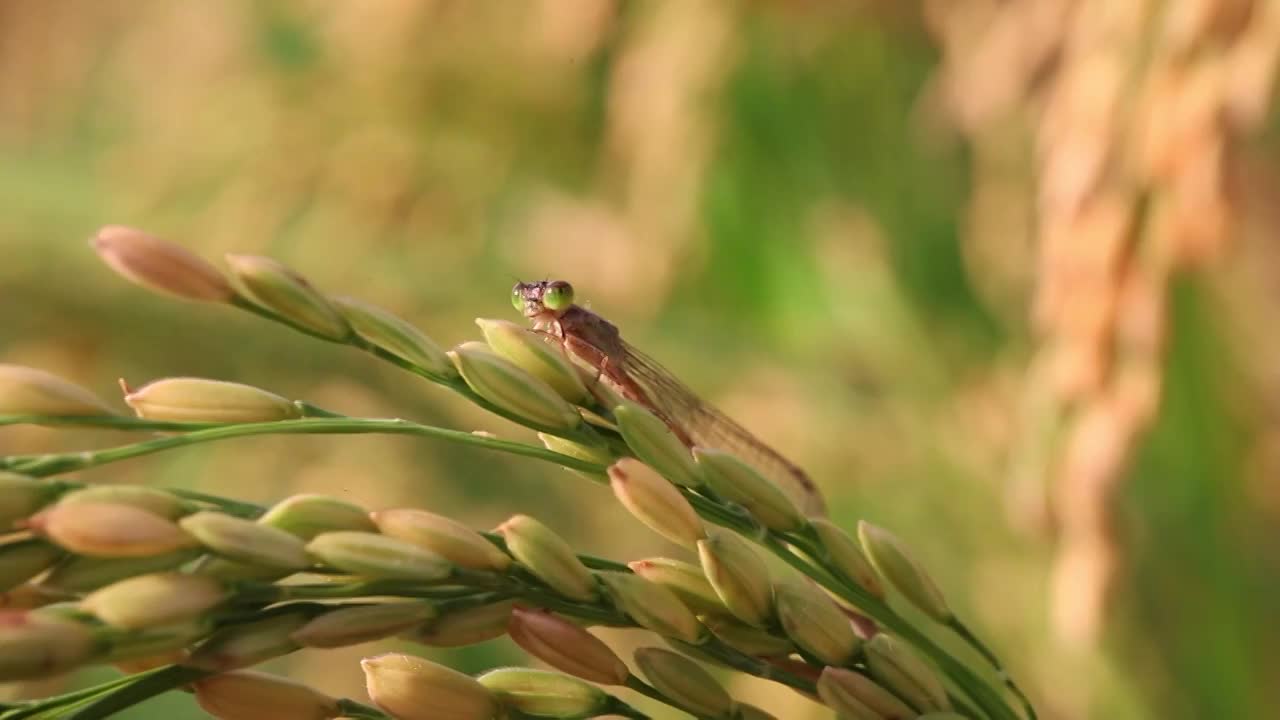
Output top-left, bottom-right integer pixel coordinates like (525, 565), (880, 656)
(622, 342), (826, 515)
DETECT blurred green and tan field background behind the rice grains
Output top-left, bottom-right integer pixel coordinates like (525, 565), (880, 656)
(0, 0), (1280, 719)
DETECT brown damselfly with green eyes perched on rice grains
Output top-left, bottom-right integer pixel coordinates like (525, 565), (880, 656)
(511, 281), (824, 515)
